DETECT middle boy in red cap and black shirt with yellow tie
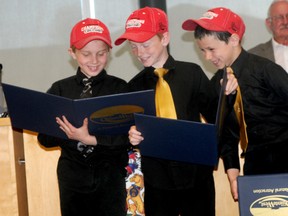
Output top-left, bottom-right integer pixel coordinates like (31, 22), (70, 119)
(115, 7), (237, 216)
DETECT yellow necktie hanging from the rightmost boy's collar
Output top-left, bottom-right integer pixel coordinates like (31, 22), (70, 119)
(227, 67), (248, 153)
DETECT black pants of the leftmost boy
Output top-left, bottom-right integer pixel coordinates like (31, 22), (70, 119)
(58, 163), (127, 216)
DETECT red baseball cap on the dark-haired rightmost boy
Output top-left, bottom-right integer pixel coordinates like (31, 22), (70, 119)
(182, 7), (245, 39)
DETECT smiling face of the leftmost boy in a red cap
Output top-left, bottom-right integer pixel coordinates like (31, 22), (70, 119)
(69, 40), (109, 78)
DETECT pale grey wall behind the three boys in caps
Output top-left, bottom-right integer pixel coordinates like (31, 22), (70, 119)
(0, 0), (272, 95)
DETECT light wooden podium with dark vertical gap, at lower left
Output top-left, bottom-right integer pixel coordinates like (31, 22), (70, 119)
(0, 118), (61, 216)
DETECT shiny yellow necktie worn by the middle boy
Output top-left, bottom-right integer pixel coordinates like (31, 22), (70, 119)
(154, 68), (177, 119)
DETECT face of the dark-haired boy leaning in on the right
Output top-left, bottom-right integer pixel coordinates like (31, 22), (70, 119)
(197, 35), (239, 69)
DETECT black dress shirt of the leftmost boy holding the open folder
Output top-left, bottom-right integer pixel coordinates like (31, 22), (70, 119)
(38, 68), (129, 192)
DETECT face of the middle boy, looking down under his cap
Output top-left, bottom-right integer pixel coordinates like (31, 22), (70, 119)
(129, 35), (169, 68)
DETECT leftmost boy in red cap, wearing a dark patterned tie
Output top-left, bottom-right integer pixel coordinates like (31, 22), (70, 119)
(38, 18), (128, 216)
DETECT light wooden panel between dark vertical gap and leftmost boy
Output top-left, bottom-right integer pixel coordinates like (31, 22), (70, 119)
(24, 131), (61, 216)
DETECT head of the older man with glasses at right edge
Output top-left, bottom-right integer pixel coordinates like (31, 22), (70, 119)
(266, 1), (288, 45)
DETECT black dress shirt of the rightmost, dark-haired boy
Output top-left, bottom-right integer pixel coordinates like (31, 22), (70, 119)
(211, 50), (288, 174)
